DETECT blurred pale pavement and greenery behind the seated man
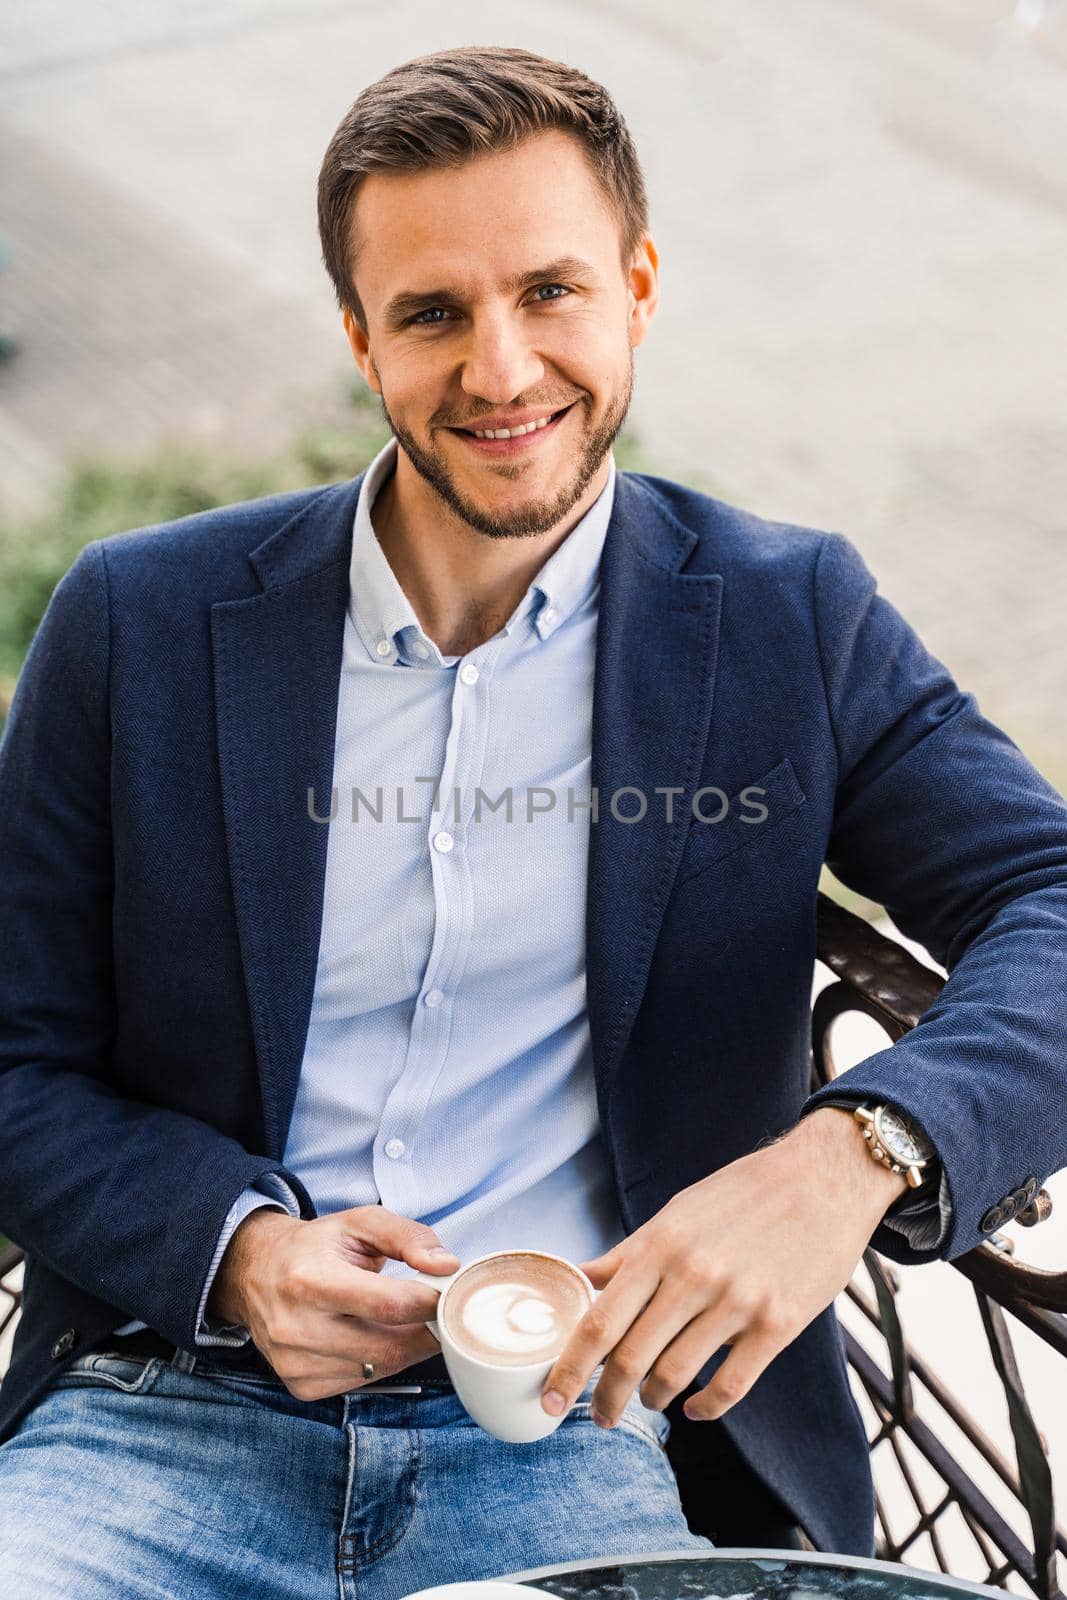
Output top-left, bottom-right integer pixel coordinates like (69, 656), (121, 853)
(0, 0), (1067, 1587)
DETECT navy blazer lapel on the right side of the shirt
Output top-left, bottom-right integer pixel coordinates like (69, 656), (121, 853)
(585, 474), (723, 1104)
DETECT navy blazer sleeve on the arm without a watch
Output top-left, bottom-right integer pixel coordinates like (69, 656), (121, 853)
(0, 542), (315, 1349)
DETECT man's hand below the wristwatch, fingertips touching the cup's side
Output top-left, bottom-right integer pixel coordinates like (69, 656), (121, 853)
(542, 1106), (907, 1427)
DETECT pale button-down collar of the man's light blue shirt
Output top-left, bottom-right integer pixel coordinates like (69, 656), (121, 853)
(349, 438), (616, 666)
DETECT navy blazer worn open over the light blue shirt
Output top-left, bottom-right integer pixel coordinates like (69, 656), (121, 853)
(0, 474), (1067, 1554)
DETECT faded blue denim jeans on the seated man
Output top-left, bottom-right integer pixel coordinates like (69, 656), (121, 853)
(0, 1350), (712, 1600)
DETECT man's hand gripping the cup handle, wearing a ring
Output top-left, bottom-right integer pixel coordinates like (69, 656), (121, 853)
(208, 1205), (459, 1400)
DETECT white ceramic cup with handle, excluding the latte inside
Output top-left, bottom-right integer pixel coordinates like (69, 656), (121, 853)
(416, 1250), (597, 1445)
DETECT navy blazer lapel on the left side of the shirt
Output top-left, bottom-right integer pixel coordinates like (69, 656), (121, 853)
(211, 478), (362, 1162)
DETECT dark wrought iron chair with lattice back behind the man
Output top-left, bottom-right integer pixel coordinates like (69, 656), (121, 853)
(0, 894), (1067, 1600)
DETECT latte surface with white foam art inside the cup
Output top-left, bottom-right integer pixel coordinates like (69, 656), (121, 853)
(445, 1251), (590, 1366)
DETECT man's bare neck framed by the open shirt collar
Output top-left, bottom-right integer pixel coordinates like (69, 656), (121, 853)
(371, 450), (611, 656)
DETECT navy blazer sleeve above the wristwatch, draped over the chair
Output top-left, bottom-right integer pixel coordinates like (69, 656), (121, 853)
(803, 534), (1067, 1262)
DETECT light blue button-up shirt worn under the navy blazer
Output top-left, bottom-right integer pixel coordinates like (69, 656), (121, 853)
(167, 440), (624, 1346)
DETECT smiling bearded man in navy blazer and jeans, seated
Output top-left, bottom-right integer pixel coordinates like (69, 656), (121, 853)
(0, 48), (1067, 1600)
